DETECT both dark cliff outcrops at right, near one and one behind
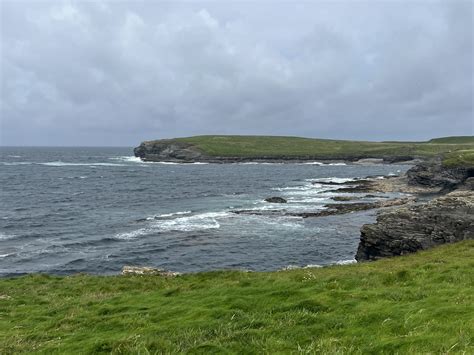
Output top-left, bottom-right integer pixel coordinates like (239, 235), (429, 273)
(355, 162), (474, 261)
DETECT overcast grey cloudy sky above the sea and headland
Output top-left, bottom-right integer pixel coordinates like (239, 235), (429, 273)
(0, 0), (474, 146)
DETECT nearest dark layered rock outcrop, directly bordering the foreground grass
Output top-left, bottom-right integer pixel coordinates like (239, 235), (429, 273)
(355, 190), (474, 261)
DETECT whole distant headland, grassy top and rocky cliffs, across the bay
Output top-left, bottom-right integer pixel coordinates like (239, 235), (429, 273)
(134, 136), (474, 163)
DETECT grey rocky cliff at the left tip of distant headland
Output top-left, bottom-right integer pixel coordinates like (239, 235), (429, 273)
(134, 140), (204, 162)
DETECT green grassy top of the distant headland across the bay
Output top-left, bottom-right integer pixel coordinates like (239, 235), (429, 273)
(175, 136), (474, 158)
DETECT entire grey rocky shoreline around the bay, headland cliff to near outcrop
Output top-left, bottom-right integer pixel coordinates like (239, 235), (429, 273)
(134, 140), (474, 272)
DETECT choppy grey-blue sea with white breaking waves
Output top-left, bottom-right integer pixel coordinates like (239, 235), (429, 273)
(0, 147), (408, 275)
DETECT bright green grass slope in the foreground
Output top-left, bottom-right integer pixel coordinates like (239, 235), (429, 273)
(0, 241), (474, 354)
